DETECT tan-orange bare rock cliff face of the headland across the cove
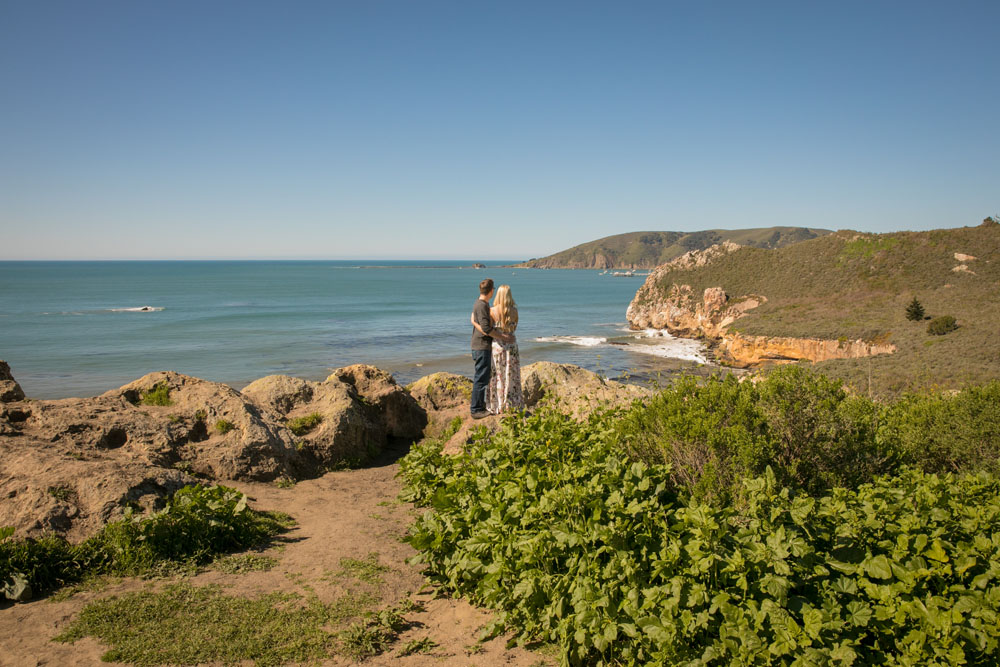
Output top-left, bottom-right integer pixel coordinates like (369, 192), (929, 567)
(626, 243), (896, 368)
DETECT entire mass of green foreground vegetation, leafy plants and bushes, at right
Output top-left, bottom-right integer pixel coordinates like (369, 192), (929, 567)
(401, 367), (1000, 665)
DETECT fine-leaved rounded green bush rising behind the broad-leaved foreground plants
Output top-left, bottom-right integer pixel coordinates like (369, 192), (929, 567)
(616, 366), (898, 504)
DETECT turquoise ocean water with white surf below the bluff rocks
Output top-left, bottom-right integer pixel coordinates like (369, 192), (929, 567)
(0, 261), (702, 398)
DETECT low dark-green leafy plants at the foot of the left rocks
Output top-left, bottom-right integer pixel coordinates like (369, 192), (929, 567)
(0, 485), (292, 597)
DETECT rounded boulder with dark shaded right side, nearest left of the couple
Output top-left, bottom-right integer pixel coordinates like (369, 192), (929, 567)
(331, 364), (427, 440)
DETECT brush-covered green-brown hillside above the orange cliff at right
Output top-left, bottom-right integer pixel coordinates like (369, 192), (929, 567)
(640, 219), (1000, 395)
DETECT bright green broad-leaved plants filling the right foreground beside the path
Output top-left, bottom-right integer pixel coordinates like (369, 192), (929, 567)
(401, 410), (1000, 665)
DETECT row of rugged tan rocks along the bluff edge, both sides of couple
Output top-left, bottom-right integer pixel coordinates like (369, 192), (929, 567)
(0, 361), (649, 541)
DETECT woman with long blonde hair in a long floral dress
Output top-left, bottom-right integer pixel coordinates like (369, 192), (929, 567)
(472, 285), (524, 414)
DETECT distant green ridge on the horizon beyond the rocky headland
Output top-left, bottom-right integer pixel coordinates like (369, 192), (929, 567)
(516, 227), (832, 269)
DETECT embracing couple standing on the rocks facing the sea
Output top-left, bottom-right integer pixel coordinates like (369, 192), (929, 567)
(469, 278), (524, 419)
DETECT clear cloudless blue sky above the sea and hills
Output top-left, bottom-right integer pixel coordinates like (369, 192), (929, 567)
(0, 0), (1000, 259)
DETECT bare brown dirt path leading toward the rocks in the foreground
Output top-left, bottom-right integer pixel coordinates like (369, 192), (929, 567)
(0, 444), (555, 667)
